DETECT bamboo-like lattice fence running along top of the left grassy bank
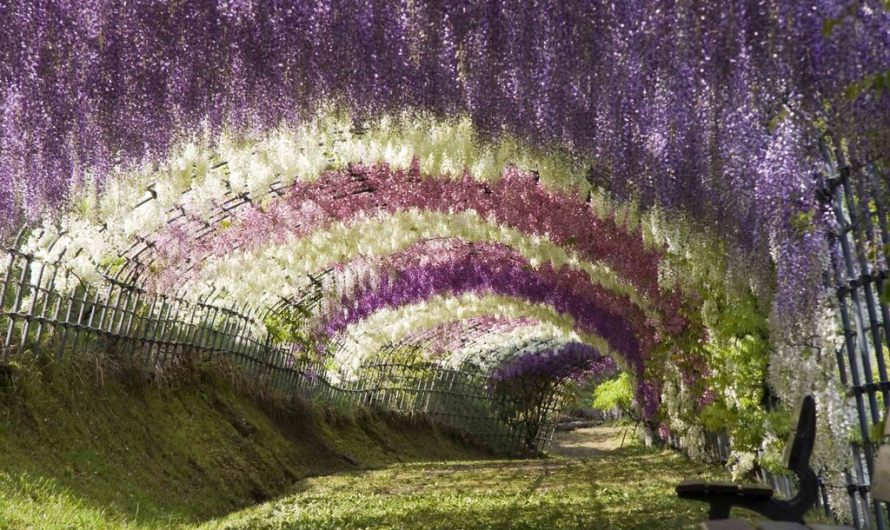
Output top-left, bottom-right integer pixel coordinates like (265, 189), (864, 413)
(0, 234), (562, 454)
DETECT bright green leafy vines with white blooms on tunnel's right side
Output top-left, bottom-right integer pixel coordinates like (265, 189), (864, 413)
(646, 223), (772, 458)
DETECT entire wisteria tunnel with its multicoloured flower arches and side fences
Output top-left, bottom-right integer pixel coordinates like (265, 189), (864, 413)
(0, 4), (890, 528)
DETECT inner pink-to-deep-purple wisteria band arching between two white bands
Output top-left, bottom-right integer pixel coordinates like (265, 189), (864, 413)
(320, 240), (655, 367)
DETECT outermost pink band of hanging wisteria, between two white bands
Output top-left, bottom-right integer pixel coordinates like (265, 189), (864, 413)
(149, 164), (683, 318)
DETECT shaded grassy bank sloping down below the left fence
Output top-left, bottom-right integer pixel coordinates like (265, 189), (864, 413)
(0, 352), (482, 529)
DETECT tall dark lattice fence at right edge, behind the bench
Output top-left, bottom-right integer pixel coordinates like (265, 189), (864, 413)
(818, 143), (890, 530)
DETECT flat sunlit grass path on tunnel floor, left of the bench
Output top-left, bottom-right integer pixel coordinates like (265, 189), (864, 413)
(202, 434), (725, 530)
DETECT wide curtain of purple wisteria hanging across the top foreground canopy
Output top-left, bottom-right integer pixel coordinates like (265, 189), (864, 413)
(0, 0), (890, 234)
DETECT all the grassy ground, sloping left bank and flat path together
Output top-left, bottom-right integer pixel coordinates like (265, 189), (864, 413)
(0, 350), (836, 530)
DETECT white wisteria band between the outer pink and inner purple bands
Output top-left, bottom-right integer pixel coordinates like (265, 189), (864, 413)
(177, 210), (660, 318)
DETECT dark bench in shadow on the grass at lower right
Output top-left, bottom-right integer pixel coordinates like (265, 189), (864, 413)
(676, 396), (819, 520)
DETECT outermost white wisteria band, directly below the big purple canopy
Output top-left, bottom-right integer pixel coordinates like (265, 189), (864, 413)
(8, 107), (588, 282)
